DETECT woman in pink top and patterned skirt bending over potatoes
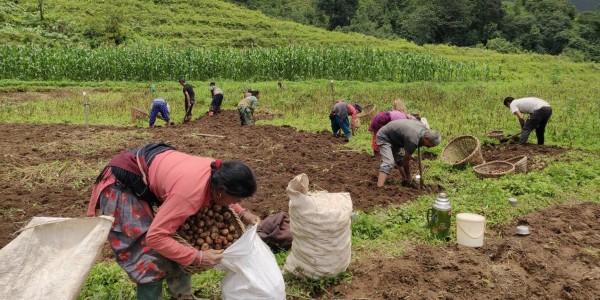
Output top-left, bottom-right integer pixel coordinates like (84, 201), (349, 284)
(87, 144), (260, 299)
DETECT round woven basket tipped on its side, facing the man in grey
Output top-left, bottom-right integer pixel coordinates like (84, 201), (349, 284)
(440, 135), (485, 166)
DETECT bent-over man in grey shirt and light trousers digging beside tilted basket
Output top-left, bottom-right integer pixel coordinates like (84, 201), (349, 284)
(376, 120), (442, 187)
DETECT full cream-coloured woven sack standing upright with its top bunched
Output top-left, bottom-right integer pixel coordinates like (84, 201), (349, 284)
(283, 174), (352, 278)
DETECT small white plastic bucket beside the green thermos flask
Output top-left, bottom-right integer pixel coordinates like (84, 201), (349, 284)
(456, 213), (485, 247)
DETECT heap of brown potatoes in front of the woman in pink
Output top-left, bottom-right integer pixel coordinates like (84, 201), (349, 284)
(177, 204), (242, 250)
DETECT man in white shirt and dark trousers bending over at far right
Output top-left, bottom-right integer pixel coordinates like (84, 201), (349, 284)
(504, 97), (552, 145)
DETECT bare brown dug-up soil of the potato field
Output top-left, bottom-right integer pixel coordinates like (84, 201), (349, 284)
(0, 111), (600, 299)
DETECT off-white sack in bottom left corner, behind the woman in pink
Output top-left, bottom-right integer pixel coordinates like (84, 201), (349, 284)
(0, 216), (113, 300)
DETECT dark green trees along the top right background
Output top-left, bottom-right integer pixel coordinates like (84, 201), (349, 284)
(228, 0), (600, 62)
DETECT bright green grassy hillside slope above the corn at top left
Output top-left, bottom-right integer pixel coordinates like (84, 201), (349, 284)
(0, 0), (418, 50)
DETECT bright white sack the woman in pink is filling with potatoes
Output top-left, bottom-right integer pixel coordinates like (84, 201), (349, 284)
(216, 226), (285, 300)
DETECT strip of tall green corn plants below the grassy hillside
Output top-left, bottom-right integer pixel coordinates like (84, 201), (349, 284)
(0, 45), (501, 82)
